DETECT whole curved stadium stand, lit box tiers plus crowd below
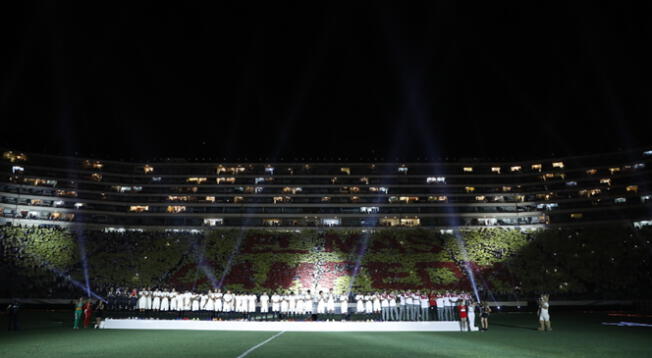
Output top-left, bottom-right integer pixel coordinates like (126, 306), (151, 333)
(0, 150), (652, 356)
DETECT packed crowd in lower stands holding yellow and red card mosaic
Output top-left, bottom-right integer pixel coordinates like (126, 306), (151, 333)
(0, 225), (652, 300)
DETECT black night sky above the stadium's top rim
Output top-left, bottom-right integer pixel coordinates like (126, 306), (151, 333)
(0, 1), (652, 160)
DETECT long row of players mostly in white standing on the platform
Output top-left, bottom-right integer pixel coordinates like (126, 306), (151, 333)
(107, 289), (474, 321)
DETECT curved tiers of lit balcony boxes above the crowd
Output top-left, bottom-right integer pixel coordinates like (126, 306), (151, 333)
(0, 149), (652, 231)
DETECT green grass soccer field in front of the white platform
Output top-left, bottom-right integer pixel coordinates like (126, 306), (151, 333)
(0, 312), (652, 358)
